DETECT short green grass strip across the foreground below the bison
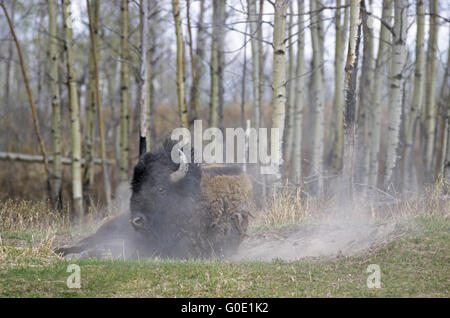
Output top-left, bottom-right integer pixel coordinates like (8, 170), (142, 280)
(0, 217), (450, 297)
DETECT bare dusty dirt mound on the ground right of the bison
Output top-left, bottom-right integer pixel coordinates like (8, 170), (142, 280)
(230, 222), (405, 261)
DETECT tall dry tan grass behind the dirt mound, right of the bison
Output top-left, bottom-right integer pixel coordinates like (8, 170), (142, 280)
(251, 179), (450, 229)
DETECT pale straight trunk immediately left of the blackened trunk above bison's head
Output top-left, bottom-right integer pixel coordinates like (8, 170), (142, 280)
(119, 0), (130, 179)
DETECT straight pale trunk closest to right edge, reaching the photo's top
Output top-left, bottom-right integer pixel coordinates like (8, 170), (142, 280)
(425, 0), (439, 182)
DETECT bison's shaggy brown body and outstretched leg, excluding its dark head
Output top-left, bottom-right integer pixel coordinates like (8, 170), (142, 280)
(55, 167), (253, 258)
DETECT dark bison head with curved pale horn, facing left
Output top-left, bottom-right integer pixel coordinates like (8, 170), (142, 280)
(130, 140), (201, 251)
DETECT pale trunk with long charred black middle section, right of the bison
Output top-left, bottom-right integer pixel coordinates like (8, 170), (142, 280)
(343, 0), (361, 195)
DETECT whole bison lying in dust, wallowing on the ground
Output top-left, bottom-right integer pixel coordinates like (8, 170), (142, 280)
(56, 139), (252, 258)
